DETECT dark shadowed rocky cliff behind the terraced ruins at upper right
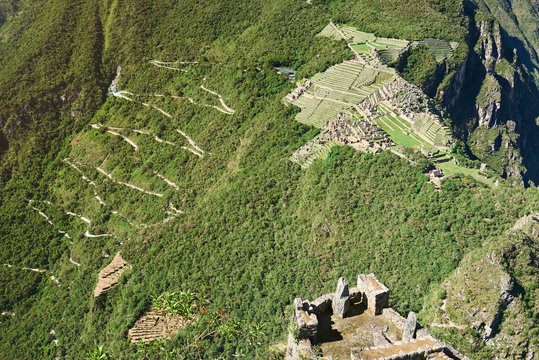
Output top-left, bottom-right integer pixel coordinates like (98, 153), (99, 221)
(439, 9), (539, 183)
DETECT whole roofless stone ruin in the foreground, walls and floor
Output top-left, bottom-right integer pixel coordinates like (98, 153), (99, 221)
(285, 274), (468, 360)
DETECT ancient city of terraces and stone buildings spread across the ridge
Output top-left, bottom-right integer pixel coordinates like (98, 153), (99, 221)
(284, 21), (458, 168)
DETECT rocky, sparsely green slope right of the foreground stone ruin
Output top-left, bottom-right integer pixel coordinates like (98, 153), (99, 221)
(422, 213), (539, 359)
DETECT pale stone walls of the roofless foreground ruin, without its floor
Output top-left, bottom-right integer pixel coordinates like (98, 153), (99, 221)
(285, 274), (468, 360)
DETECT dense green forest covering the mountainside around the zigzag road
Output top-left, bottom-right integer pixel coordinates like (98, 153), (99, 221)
(0, 0), (537, 359)
